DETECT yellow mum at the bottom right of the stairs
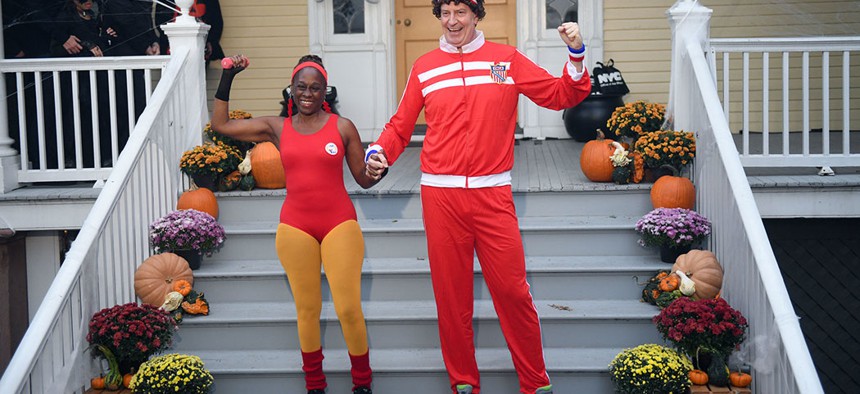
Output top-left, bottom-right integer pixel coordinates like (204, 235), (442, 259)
(609, 344), (692, 394)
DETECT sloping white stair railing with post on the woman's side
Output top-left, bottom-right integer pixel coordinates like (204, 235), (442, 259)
(0, 11), (208, 394)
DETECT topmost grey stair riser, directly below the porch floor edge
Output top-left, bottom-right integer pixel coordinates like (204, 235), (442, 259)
(218, 190), (652, 223)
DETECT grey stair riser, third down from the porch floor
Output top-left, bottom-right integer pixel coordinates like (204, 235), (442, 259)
(194, 270), (656, 303)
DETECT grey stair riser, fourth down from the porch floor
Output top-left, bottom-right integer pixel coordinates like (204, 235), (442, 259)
(173, 313), (660, 354)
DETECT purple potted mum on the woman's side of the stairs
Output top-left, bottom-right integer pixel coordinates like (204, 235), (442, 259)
(149, 209), (227, 269)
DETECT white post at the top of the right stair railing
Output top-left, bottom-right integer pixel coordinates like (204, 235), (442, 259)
(666, 0), (713, 131)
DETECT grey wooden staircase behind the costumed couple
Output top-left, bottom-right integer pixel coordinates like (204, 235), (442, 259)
(174, 143), (668, 394)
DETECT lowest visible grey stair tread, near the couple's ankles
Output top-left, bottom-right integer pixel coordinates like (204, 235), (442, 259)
(195, 348), (623, 374)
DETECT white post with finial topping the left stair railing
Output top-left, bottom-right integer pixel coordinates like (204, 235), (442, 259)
(161, 0), (210, 146)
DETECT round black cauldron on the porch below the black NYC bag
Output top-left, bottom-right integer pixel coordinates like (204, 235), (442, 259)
(561, 94), (624, 142)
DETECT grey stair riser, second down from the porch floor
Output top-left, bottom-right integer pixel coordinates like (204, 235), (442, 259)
(212, 228), (655, 260)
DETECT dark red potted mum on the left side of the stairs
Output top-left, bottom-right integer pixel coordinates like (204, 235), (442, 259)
(87, 302), (176, 375)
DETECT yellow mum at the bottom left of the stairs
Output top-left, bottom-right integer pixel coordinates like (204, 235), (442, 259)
(129, 353), (215, 394)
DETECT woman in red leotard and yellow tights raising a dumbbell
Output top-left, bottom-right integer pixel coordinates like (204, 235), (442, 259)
(211, 55), (381, 394)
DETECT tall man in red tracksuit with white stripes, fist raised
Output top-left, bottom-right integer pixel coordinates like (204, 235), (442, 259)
(365, 0), (591, 394)
